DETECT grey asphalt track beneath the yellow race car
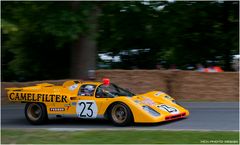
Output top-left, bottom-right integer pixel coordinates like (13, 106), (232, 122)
(1, 102), (239, 131)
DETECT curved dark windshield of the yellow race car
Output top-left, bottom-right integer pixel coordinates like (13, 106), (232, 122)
(97, 83), (135, 97)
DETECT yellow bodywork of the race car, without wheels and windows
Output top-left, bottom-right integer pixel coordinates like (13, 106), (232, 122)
(7, 80), (189, 123)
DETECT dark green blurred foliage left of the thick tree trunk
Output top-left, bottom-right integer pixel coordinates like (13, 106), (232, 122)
(1, 2), (94, 81)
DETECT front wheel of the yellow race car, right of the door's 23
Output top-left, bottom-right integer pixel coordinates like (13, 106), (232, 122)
(108, 102), (133, 126)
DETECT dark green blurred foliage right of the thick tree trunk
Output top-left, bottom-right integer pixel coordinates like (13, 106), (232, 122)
(98, 1), (239, 70)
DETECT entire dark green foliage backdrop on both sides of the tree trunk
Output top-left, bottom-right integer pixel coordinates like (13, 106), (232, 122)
(1, 1), (239, 81)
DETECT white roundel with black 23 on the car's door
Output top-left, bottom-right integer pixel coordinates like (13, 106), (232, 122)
(76, 100), (98, 118)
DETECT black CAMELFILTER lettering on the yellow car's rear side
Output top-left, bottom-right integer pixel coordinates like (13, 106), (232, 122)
(8, 93), (67, 103)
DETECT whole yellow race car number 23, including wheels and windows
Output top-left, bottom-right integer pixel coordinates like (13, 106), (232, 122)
(6, 79), (189, 126)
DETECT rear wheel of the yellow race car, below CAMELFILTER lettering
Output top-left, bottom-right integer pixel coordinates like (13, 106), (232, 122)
(25, 102), (48, 125)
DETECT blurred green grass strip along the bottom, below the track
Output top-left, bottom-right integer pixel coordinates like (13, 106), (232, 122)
(1, 129), (239, 144)
